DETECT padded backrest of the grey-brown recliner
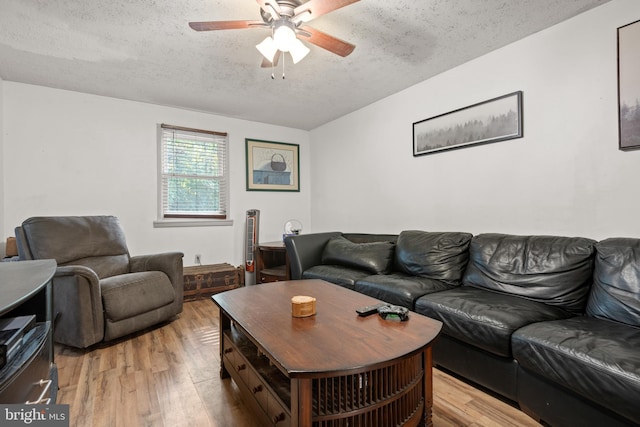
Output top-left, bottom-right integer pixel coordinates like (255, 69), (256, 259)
(22, 216), (129, 279)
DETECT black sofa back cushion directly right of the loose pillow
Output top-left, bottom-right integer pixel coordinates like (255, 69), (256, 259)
(395, 230), (473, 282)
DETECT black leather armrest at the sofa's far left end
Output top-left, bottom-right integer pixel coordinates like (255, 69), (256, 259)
(284, 231), (342, 280)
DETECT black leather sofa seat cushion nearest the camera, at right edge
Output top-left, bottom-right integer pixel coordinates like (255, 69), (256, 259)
(513, 317), (640, 424)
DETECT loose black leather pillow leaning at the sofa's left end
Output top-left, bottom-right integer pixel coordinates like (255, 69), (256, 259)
(322, 236), (395, 274)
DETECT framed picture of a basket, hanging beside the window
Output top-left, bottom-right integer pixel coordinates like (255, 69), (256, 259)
(245, 138), (300, 191)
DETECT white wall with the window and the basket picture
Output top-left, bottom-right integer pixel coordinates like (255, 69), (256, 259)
(0, 82), (310, 265)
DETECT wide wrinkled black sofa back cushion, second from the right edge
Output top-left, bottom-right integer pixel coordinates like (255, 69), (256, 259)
(463, 234), (596, 313)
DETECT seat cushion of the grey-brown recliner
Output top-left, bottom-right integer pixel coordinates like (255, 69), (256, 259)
(100, 271), (175, 321)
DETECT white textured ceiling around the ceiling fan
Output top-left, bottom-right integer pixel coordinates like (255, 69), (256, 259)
(0, 0), (609, 130)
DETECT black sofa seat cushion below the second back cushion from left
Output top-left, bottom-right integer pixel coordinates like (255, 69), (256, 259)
(355, 273), (451, 310)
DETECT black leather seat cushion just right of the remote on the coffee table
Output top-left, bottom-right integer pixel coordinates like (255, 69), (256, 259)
(415, 286), (572, 357)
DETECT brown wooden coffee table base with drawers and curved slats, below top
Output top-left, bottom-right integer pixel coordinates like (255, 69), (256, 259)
(222, 323), (431, 427)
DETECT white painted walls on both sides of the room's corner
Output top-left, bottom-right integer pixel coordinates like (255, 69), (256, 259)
(0, 0), (640, 265)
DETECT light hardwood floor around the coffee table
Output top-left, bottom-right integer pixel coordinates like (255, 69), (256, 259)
(56, 299), (539, 427)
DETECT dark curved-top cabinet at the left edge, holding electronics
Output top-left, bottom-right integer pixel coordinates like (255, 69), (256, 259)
(0, 260), (58, 404)
